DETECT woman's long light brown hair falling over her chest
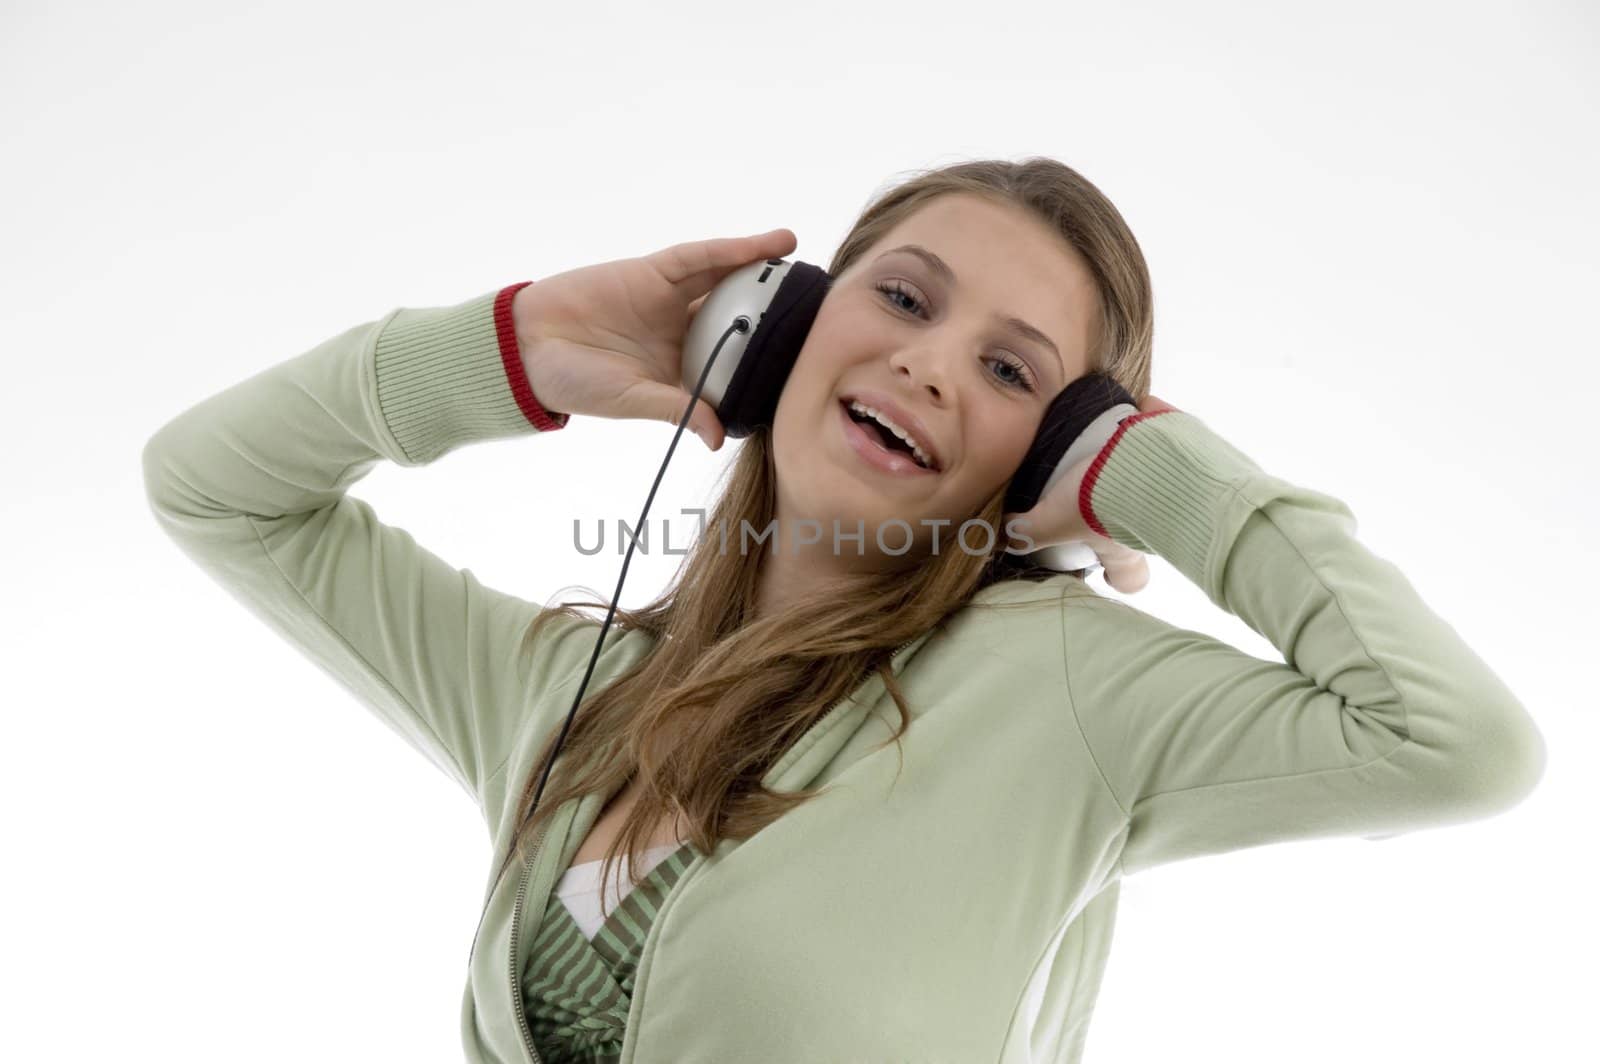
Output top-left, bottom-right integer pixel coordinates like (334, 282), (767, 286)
(496, 157), (1154, 902)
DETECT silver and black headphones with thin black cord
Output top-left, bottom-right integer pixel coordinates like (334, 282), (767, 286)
(530, 259), (1139, 838)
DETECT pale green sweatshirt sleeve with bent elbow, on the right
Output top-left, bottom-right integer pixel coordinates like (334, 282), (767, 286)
(1061, 411), (1546, 875)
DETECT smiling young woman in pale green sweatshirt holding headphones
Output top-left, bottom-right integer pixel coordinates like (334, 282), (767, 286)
(144, 158), (1544, 1064)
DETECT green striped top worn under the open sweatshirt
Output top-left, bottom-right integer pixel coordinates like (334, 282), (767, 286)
(522, 843), (694, 1064)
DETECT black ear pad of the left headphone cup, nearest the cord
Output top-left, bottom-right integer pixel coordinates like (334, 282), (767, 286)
(717, 261), (834, 438)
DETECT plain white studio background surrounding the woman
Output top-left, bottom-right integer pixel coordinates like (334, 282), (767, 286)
(0, 0), (1600, 1064)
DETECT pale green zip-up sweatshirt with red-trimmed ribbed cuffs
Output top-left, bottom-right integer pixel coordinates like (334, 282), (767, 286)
(144, 282), (1546, 1064)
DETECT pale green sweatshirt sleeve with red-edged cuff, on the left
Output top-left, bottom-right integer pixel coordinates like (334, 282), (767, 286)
(144, 282), (597, 808)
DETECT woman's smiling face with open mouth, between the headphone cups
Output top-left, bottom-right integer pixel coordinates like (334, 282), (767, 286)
(773, 194), (1099, 557)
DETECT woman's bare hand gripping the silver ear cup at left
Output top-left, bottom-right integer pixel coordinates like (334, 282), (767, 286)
(512, 229), (797, 451)
